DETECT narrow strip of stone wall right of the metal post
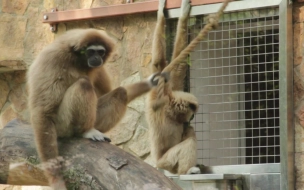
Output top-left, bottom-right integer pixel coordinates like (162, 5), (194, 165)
(293, 0), (304, 190)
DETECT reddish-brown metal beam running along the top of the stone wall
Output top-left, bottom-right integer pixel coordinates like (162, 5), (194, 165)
(43, 0), (224, 23)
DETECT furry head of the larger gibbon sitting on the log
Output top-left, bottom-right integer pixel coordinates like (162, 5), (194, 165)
(60, 29), (115, 68)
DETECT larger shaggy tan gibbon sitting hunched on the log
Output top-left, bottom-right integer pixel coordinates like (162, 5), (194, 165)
(27, 29), (165, 190)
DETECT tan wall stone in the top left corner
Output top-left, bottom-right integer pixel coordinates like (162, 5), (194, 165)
(2, 0), (30, 15)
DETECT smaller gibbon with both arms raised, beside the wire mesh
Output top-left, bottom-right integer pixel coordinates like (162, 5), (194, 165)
(146, 0), (200, 174)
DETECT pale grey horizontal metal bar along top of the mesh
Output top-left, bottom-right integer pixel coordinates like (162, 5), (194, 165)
(168, 0), (282, 18)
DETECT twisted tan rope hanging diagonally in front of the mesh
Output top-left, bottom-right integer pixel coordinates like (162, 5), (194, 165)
(153, 0), (232, 110)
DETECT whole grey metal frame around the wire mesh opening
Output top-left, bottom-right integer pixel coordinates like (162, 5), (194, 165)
(168, 0), (295, 190)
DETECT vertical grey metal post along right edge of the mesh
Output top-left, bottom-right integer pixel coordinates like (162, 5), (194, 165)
(279, 0), (295, 190)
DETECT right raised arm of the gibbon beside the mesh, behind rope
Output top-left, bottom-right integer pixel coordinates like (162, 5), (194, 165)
(171, 0), (191, 90)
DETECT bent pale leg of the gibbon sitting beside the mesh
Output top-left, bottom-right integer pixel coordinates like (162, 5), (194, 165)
(157, 127), (200, 174)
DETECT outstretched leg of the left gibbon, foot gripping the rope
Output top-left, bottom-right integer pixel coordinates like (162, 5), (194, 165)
(95, 74), (157, 132)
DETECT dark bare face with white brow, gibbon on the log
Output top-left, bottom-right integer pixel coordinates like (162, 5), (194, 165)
(81, 45), (107, 68)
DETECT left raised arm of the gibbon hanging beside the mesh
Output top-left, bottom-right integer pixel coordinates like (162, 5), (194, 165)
(152, 0), (167, 73)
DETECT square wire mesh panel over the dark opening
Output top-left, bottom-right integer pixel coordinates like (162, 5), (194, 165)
(188, 8), (280, 166)
